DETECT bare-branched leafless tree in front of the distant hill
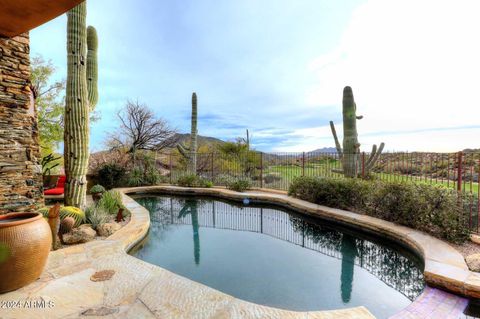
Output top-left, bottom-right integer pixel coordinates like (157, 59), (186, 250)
(107, 101), (177, 157)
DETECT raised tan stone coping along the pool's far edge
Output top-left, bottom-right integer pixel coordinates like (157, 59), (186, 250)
(121, 185), (480, 298)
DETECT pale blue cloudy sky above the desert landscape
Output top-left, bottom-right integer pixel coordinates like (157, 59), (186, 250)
(30, 0), (480, 152)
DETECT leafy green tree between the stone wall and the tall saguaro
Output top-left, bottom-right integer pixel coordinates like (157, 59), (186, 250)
(31, 56), (65, 157)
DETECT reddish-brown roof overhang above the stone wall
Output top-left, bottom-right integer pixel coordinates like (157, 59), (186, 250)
(0, 0), (84, 38)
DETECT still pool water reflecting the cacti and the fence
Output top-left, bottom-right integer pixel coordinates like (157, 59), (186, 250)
(130, 195), (424, 318)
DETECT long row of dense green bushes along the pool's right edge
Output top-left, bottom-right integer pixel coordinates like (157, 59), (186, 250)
(288, 177), (469, 242)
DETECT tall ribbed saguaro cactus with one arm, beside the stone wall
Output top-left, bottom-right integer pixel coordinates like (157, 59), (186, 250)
(64, 2), (98, 208)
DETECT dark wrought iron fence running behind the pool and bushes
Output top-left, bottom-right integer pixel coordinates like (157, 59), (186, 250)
(156, 151), (480, 232)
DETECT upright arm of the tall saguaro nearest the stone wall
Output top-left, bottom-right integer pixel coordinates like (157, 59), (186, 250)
(87, 26), (98, 111)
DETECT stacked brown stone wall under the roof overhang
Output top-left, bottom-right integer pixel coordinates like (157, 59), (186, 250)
(0, 34), (43, 214)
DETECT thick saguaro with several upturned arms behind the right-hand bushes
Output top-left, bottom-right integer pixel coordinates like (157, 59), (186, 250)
(330, 86), (385, 177)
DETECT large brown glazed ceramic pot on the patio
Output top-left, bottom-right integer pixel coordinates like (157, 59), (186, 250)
(0, 213), (52, 293)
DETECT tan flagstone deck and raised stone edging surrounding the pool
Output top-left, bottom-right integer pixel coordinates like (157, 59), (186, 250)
(0, 186), (472, 319)
